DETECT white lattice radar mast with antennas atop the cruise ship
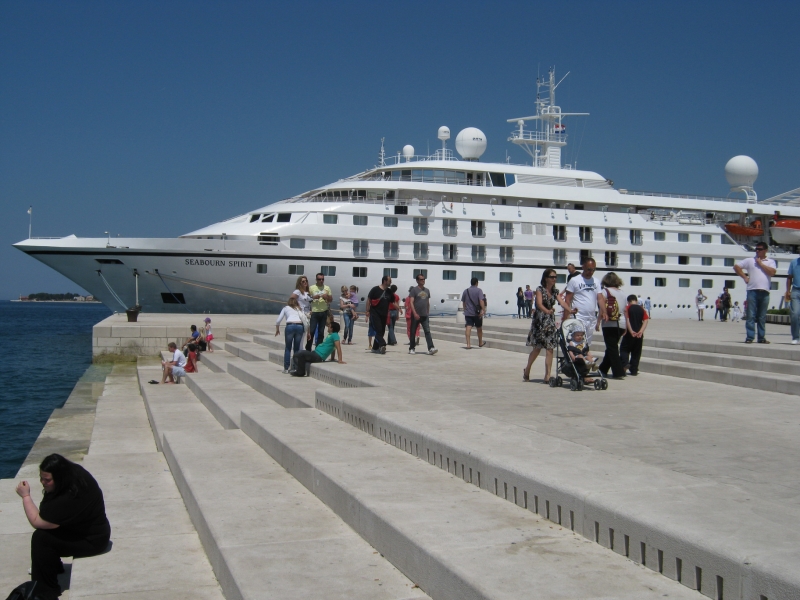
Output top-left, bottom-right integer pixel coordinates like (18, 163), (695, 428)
(508, 67), (589, 169)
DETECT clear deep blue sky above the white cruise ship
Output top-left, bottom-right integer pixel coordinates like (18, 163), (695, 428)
(0, 0), (800, 298)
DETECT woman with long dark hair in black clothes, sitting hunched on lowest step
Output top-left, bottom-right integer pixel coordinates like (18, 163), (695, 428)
(17, 454), (111, 598)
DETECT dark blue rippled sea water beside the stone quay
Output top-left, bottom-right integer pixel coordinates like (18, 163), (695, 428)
(0, 300), (111, 478)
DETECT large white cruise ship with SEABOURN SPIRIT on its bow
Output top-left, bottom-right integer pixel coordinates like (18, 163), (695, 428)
(15, 70), (800, 318)
